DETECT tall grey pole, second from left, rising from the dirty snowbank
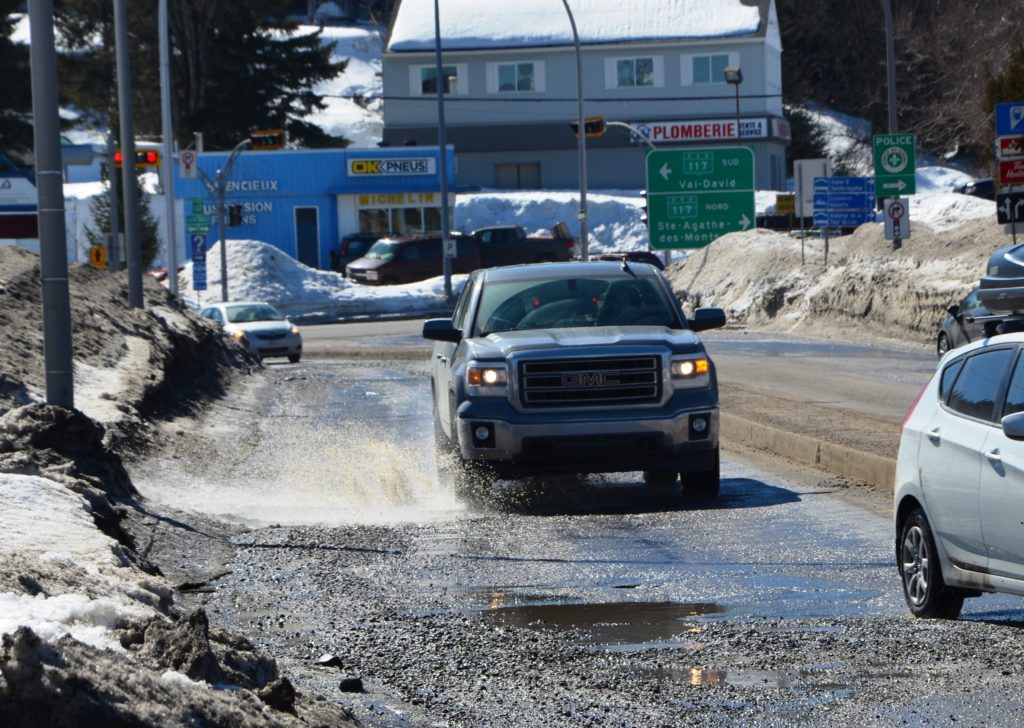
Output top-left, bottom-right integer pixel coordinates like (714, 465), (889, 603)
(114, 0), (142, 308)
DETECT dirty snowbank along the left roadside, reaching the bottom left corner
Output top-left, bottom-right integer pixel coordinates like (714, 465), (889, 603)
(0, 246), (356, 726)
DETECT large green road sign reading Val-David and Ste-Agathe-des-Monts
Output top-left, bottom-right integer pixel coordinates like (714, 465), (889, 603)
(647, 146), (757, 250)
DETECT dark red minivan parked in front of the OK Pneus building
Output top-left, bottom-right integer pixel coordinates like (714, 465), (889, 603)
(345, 233), (480, 286)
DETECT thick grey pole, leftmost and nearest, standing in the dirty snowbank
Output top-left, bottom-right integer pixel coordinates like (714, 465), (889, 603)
(29, 0), (75, 410)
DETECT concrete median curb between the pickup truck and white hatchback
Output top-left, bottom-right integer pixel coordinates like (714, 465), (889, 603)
(719, 413), (896, 489)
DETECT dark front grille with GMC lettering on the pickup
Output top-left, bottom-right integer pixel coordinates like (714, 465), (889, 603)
(519, 356), (662, 408)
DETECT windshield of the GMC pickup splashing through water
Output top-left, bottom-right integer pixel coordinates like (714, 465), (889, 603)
(474, 277), (680, 336)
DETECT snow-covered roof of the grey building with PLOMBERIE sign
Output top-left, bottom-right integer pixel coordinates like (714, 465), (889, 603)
(388, 0), (771, 51)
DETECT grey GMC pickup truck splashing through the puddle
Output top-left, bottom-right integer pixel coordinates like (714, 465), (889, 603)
(423, 261), (725, 500)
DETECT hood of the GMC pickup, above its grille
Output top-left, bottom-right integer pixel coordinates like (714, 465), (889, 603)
(466, 326), (703, 358)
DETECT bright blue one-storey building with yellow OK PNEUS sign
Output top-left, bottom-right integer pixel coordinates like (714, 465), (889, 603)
(174, 146), (456, 268)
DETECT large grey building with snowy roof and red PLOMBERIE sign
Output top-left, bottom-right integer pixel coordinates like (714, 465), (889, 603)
(383, 0), (790, 189)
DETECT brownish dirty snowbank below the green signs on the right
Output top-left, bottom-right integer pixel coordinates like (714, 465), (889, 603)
(667, 213), (1011, 343)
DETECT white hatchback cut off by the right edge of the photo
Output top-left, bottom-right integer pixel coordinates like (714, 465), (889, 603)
(895, 333), (1024, 618)
